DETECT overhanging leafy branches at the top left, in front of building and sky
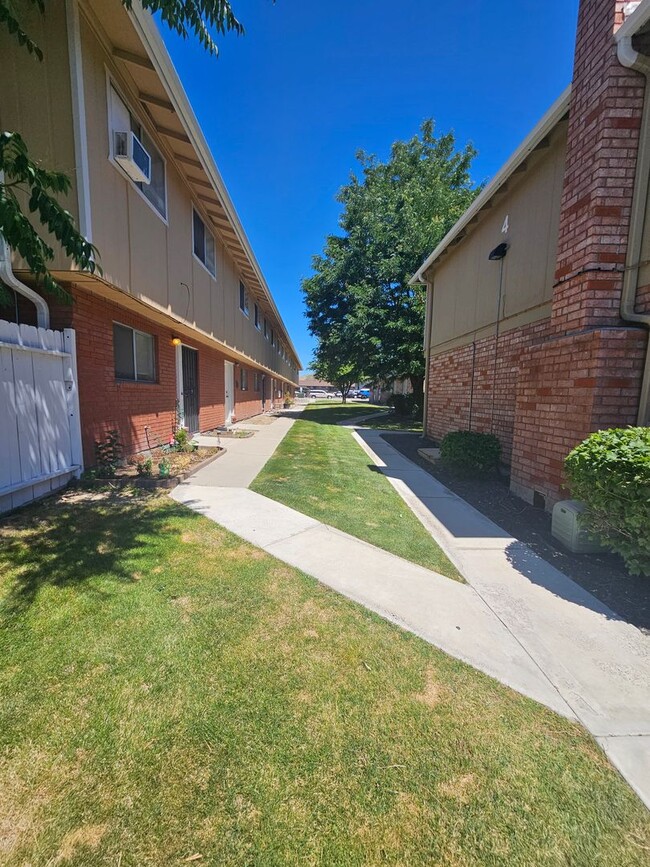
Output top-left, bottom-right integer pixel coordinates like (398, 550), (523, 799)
(0, 0), (244, 302)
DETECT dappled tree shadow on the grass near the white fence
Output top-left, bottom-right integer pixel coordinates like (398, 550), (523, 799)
(0, 491), (198, 618)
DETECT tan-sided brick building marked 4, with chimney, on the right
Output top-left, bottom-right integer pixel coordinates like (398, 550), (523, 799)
(413, 0), (650, 508)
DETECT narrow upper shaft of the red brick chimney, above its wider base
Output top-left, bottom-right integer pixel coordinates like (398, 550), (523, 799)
(553, 0), (645, 332)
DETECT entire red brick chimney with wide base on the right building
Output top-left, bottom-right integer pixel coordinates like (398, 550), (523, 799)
(512, 0), (647, 508)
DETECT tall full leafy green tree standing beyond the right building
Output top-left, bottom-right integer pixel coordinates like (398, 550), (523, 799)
(303, 120), (479, 402)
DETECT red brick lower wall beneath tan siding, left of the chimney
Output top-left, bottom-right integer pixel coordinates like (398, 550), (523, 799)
(427, 318), (549, 463)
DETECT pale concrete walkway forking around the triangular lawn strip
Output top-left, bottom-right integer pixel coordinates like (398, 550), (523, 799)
(173, 417), (650, 806)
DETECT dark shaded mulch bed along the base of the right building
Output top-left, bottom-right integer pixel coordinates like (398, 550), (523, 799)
(383, 433), (650, 633)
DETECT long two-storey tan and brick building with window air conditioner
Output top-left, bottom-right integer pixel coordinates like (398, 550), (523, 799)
(0, 0), (301, 472)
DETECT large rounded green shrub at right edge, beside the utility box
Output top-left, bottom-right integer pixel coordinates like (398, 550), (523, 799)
(564, 427), (650, 576)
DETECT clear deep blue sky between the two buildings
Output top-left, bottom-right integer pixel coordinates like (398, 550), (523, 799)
(163, 0), (578, 366)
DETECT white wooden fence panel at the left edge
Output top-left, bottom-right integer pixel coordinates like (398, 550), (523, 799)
(0, 319), (82, 513)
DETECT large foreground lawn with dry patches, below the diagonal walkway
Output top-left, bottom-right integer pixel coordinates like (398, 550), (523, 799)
(0, 494), (650, 867)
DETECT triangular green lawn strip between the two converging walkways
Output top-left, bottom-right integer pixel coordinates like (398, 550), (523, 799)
(251, 404), (462, 580)
